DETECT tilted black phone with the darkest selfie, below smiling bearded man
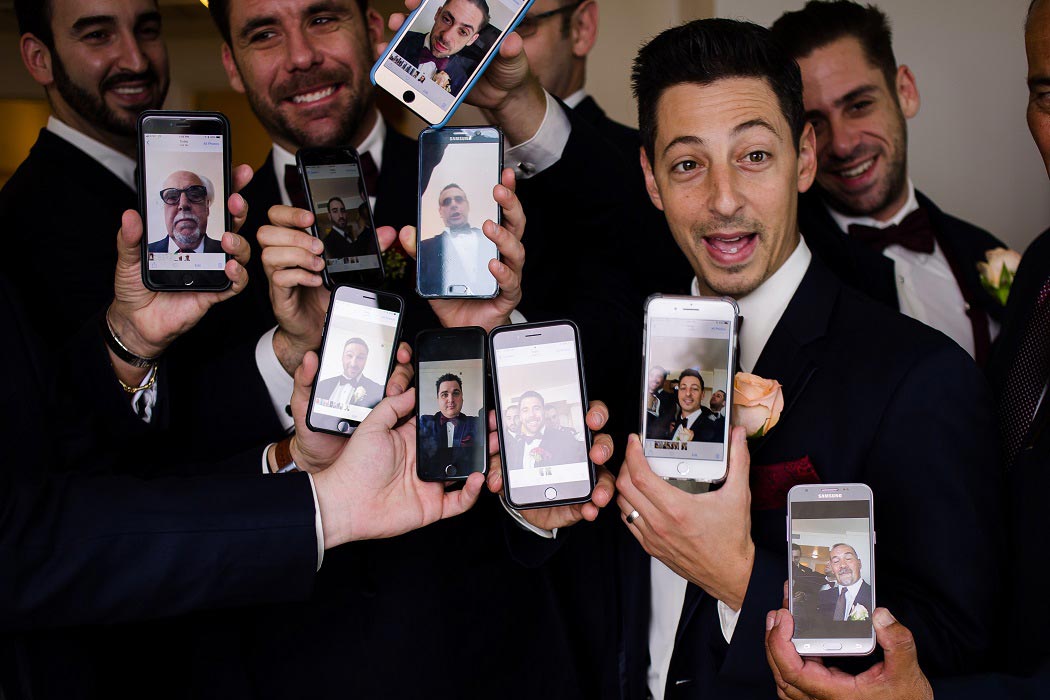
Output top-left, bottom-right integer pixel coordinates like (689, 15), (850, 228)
(295, 146), (383, 290)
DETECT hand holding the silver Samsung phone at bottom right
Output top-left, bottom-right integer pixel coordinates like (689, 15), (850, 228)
(765, 608), (933, 700)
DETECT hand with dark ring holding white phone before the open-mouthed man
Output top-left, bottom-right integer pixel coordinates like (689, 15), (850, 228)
(616, 428), (755, 611)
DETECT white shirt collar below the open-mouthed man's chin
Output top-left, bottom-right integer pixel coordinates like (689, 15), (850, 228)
(692, 237), (813, 372)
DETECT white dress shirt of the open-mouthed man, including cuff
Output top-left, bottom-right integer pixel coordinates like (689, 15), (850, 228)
(648, 239), (813, 700)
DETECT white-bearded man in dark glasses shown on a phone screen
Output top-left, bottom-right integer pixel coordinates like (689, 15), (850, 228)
(147, 170), (223, 253)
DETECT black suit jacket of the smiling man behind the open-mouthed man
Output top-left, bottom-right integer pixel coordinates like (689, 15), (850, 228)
(798, 188), (1006, 329)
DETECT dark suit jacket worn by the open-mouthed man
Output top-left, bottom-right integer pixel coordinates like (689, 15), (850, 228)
(537, 259), (1001, 699)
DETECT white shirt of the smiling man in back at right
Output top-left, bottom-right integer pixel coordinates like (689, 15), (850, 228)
(827, 179), (999, 357)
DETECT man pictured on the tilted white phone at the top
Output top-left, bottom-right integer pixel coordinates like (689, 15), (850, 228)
(397, 0), (488, 97)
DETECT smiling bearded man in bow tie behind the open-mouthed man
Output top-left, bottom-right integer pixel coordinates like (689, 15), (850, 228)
(772, 0), (1004, 364)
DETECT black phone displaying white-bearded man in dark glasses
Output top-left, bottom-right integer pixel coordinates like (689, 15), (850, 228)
(139, 110), (231, 292)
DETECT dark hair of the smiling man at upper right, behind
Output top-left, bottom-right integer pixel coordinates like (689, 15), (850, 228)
(770, 0), (897, 93)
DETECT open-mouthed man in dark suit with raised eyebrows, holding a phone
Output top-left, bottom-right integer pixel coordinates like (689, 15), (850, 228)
(512, 19), (999, 698)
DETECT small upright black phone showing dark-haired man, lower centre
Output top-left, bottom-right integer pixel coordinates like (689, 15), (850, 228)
(416, 326), (488, 482)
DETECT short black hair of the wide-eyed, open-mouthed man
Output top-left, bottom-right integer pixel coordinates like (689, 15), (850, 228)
(631, 19), (805, 161)
